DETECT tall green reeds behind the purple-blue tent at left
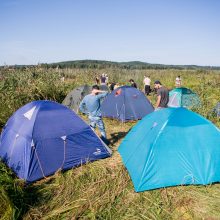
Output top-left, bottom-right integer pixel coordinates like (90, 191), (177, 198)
(0, 69), (67, 126)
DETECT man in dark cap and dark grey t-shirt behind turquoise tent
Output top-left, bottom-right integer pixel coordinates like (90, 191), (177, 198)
(154, 80), (169, 110)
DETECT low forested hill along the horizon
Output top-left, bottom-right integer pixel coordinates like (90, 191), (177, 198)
(1, 60), (220, 70)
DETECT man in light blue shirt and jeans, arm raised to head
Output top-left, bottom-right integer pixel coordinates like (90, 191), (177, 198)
(79, 85), (108, 142)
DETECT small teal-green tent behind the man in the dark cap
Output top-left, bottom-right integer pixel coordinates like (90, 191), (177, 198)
(168, 87), (200, 108)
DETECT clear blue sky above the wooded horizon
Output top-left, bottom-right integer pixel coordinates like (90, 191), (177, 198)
(0, 0), (220, 66)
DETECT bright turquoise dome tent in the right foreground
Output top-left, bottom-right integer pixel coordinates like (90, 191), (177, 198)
(118, 108), (220, 192)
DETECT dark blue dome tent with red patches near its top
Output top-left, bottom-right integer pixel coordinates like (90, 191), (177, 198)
(101, 86), (154, 122)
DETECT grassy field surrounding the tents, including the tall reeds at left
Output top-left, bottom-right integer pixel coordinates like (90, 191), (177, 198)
(0, 67), (220, 219)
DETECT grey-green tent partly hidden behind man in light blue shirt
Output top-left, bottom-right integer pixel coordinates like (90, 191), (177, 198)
(62, 85), (92, 112)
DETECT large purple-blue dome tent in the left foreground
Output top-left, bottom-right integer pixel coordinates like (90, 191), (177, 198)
(0, 101), (111, 182)
